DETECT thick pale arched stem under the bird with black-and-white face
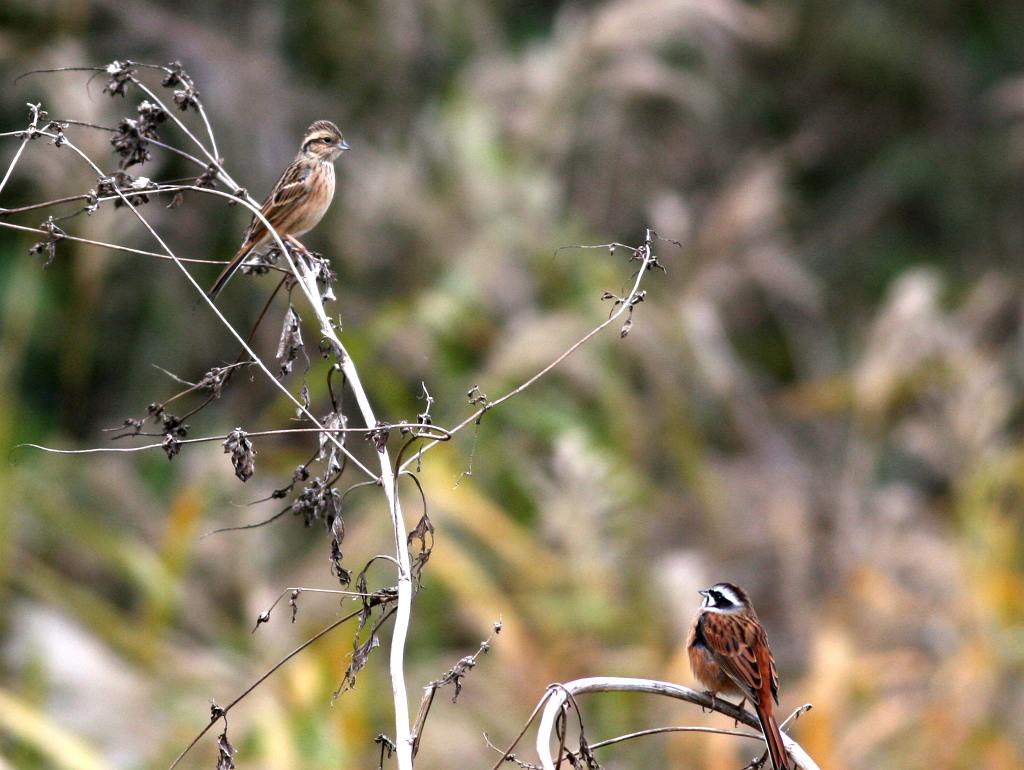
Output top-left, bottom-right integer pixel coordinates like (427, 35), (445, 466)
(537, 677), (819, 770)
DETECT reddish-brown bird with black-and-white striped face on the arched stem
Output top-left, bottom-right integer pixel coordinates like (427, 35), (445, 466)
(686, 583), (790, 770)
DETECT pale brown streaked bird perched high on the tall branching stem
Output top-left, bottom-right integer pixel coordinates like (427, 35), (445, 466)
(210, 121), (349, 299)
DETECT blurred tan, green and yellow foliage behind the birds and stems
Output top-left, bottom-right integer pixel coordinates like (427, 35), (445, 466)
(0, 0), (1024, 770)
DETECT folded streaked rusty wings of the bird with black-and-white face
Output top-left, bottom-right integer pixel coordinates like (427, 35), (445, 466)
(700, 612), (778, 705)
